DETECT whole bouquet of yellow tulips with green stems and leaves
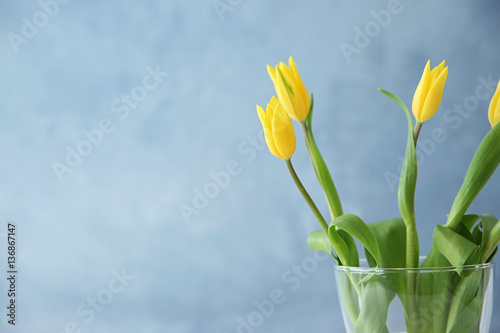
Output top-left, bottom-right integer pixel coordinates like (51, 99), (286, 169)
(257, 57), (500, 333)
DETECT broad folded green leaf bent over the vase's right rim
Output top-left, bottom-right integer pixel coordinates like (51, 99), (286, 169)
(433, 225), (479, 266)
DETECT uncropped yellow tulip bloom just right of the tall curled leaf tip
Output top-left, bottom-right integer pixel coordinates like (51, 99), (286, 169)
(412, 60), (448, 123)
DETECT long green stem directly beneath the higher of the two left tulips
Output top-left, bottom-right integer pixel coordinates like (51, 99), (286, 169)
(300, 121), (344, 220)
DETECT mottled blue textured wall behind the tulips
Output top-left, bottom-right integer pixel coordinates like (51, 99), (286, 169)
(0, 0), (500, 333)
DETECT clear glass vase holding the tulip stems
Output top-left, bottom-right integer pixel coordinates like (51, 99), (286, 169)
(335, 261), (493, 333)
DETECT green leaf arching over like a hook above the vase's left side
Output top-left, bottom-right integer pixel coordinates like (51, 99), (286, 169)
(328, 214), (380, 264)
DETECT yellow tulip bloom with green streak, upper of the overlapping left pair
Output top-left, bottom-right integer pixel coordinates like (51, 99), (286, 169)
(267, 57), (311, 122)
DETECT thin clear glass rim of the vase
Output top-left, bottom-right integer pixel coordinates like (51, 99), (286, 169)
(334, 256), (495, 274)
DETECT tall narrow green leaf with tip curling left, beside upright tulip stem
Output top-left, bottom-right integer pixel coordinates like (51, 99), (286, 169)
(379, 88), (419, 267)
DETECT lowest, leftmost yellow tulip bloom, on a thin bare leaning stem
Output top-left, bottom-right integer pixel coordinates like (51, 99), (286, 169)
(257, 96), (297, 160)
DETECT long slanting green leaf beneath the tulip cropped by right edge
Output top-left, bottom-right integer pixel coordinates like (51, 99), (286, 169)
(446, 124), (500, 230)
